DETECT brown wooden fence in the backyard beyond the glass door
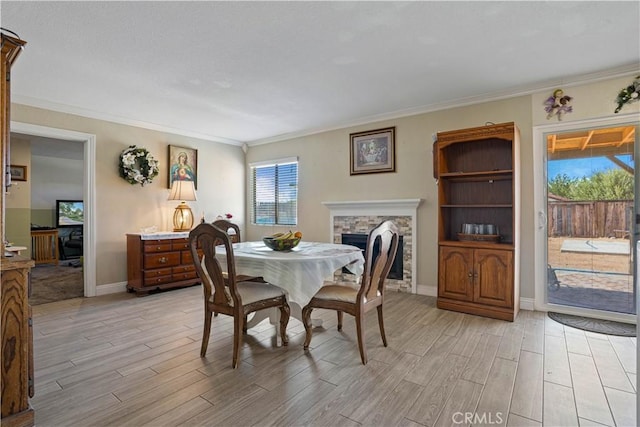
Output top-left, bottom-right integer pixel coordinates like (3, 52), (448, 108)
(547, 200), (633, 238)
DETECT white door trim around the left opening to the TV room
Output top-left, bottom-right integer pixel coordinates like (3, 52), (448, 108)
(11, 122), (97, 297)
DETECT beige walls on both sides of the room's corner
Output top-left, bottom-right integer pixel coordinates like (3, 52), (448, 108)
(12, 76), (640, 299)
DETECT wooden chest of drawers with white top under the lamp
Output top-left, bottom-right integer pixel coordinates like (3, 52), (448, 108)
(127, 233), (200, 295)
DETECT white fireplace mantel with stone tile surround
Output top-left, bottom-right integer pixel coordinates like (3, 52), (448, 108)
(322, 199), (422, 293)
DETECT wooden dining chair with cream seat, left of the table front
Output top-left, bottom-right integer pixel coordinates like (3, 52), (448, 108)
(189, 224), (290, 369)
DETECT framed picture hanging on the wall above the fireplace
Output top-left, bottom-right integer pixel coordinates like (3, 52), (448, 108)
(349, 127), (396, 175)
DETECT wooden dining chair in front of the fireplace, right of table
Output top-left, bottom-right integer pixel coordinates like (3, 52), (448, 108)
(302, 221), (399, 365)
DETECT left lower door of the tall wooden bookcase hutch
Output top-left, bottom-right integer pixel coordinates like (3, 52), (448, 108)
(438, 246), (473, 301)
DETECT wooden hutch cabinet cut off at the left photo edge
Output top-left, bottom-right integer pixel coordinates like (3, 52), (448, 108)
(0, 30), (34, 427)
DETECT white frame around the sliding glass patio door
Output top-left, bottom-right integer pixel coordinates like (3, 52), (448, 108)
(533, 113), (640, 323)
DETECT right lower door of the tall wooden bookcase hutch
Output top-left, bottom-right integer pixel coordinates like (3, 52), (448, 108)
(473, 249), (513, 308)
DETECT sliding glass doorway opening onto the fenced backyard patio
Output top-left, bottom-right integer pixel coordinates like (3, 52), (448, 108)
(534, 115), (638, 321)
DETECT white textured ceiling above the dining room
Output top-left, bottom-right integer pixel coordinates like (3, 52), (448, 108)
(0, 0), (640, 145)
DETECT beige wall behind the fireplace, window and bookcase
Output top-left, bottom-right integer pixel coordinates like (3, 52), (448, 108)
(247, 76), (640, 302)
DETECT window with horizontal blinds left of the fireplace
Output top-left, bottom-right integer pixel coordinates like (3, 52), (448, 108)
(250, 158), (298, 225)
